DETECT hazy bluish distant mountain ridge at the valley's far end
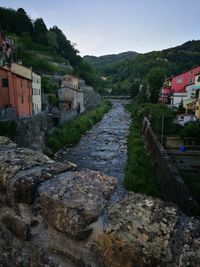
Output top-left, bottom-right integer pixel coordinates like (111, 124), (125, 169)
(84, 51), (139, 69)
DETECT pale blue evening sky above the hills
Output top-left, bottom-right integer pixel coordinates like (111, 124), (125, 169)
(0, 0), (200, 56)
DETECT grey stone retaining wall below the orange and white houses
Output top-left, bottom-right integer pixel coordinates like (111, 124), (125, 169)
(15, 112), (49, 151)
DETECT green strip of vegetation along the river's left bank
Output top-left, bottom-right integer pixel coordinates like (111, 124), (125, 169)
(47, 101), (112, 153)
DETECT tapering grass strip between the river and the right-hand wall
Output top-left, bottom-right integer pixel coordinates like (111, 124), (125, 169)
(123, 104), (161, 197)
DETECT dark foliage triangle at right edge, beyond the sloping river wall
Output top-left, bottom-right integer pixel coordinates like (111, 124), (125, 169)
(182, 174), (200, 204)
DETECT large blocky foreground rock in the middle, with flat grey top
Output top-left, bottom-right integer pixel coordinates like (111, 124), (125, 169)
(39, 170), (117, 240)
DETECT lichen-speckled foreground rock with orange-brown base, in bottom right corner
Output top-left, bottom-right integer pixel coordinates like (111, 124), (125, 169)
(93, 193), (200, 267)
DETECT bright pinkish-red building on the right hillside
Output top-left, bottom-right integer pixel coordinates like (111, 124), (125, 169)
(161, 66), (200, 103)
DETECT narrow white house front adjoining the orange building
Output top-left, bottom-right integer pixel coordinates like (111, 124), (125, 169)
(32, 72), (42, 114)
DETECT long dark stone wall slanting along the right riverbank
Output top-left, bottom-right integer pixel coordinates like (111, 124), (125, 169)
(142, 118), (200, 218)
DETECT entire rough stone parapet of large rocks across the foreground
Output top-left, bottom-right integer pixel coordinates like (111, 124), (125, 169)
(0, 137), (200, 267)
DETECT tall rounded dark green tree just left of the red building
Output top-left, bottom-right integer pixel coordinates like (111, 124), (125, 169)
(146, 67), (165, 103)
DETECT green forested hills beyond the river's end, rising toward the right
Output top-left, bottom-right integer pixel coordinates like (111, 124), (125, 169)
(86, 40), (200, 97)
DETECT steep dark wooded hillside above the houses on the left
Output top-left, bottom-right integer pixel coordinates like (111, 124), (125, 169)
(0, 7), (98, 86)
